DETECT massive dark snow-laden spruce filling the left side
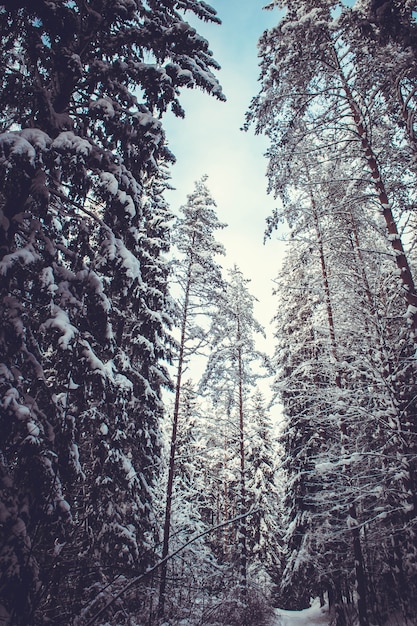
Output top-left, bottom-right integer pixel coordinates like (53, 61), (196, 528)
(0, 0), (223, 624)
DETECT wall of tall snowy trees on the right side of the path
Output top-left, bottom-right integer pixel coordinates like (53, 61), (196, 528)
(247, 1), (417, 626)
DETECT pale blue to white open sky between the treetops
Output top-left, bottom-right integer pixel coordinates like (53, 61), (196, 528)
(164, 0), (284, 336)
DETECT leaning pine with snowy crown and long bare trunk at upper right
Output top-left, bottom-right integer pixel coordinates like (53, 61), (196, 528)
(248, 0), (417, 326)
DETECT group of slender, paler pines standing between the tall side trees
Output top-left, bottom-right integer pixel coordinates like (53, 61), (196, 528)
(157, 177), (278, 625)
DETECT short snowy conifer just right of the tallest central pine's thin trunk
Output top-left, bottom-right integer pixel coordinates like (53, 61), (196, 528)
(156, 380), (222, 621)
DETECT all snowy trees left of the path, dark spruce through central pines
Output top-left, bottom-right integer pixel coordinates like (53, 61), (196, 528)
(0, 0), (277, 626)
